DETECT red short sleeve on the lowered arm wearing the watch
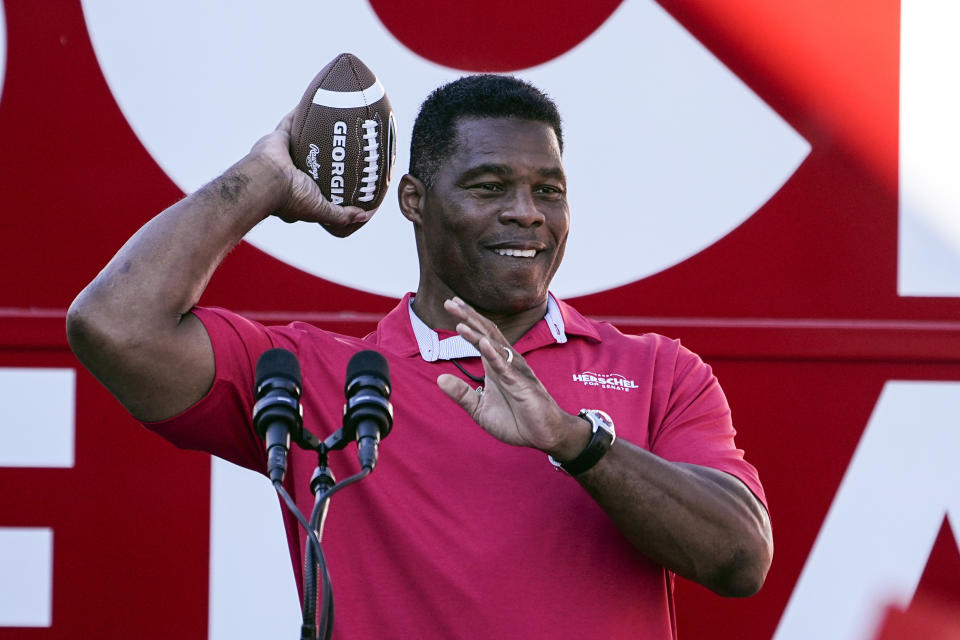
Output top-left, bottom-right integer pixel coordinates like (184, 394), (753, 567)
(651, 346), (766, 506)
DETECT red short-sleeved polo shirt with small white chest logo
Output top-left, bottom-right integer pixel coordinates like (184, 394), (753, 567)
(146, 294), (765, 639)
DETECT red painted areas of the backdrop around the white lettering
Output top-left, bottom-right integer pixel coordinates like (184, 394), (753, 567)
(0, 0), (960, 640)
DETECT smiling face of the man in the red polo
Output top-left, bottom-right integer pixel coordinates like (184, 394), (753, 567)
(420, 118), (570, 313)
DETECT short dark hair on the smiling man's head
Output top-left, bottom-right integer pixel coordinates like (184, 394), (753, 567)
(410, 74), (563, 188)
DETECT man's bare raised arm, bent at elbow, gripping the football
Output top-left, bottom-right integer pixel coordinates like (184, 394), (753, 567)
(67, 113), (372, 421)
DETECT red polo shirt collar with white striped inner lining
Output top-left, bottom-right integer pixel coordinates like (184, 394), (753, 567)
(376, 293), (600, 362)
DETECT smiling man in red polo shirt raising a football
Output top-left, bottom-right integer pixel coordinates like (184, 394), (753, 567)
(68, 76), (772, 638)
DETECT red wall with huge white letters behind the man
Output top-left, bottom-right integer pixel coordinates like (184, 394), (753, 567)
(0, 0), (960, 640)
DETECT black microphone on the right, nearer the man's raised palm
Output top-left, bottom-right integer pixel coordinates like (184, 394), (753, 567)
(343, 351), (393, 471)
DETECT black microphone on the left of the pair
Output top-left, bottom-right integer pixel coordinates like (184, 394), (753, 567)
(253, 349), (303, 482)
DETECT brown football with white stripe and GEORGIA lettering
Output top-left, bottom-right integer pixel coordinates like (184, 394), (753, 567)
(290, 53), (397, 211)
